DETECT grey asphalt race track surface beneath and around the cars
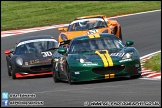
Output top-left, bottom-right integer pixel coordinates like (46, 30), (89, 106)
(1, 11), (161, 107)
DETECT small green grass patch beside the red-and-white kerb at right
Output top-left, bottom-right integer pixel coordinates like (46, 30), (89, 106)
(144, 53), (161, 72)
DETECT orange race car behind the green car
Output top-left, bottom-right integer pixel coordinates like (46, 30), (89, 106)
(58, 15), (122, 43)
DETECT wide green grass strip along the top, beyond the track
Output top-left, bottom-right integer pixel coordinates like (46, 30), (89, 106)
(1, 1), (161, 31)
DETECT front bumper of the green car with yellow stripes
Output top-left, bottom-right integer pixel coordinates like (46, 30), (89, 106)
(69, 60), (141, 82)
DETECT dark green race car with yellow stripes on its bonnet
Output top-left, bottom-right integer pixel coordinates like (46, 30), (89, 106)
(52, 33), (141, 84)
